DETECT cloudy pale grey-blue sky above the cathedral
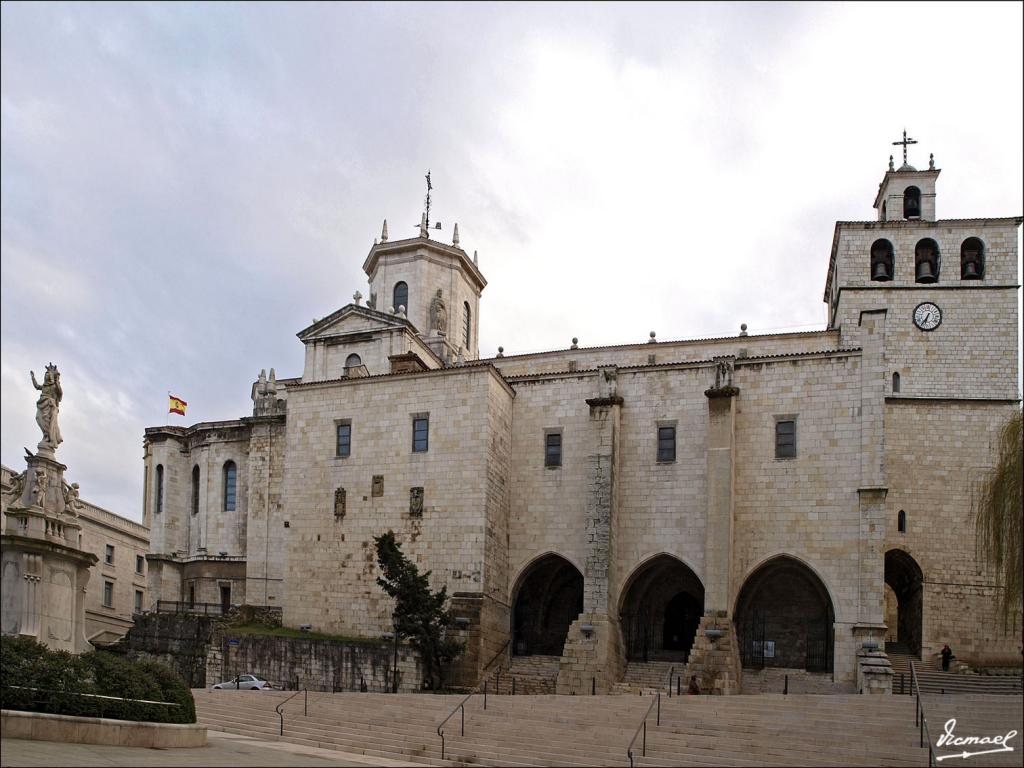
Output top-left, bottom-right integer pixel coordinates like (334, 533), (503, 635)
(0, 2), (1024, 519)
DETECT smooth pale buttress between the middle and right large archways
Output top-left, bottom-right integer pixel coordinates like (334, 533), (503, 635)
(686, 357), (741, 694)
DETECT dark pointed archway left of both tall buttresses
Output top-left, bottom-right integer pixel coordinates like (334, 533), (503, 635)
(512, 554), (583, 655)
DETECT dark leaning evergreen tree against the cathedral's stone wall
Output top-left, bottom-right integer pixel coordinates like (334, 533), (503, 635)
(374, 530), (463, 687)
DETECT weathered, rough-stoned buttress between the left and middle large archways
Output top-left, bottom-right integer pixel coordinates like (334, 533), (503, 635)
(555, 366), (625, 694)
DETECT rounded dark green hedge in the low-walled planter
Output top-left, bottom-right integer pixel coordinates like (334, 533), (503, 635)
(0, 637), (196, 723)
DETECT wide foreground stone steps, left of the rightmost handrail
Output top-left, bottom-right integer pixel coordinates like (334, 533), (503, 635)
(194, 690), (931, 766)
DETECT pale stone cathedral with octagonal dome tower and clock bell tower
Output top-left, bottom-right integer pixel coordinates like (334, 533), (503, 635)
(144, 145), (1022, 692)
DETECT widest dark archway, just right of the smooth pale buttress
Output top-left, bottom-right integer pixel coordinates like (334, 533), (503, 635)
(734, 555), (836, 672)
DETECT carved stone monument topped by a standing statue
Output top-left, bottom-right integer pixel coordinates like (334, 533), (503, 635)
(0, 365), (98, 652)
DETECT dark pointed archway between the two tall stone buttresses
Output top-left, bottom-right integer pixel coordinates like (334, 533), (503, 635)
(620, 555), (703, 663)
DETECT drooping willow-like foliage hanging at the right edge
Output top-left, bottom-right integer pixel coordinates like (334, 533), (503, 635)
(974, 409), (1024, 622)
